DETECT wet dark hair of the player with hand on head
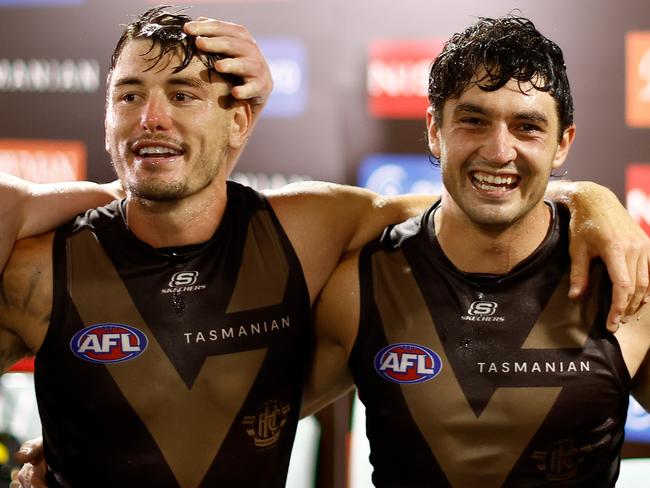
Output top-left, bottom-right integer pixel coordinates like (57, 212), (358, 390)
(109, 5), (241, 86)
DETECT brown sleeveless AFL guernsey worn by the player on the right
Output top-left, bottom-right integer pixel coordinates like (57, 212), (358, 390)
(349, 201), (630, 488)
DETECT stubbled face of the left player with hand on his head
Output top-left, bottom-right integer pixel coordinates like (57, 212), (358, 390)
(105, 40), (237, 201)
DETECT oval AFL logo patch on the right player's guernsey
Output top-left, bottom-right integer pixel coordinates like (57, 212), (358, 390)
(375, 343), (442, 383)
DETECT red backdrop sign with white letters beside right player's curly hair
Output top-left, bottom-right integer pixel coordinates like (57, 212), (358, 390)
(366, 39), (445, 119)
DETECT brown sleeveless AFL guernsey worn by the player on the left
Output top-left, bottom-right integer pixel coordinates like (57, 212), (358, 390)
(35, 183), (309, 488)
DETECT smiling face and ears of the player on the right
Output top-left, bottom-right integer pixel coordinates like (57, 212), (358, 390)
(428, 80), (575, 231)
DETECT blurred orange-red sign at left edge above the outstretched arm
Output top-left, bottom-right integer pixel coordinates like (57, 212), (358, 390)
(0, 139), (86, 183)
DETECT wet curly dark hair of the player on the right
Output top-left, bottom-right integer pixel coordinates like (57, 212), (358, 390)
(429, 15), (573, 139)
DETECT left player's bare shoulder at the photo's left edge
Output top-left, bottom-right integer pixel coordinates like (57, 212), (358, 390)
(0, 233), (54, 357)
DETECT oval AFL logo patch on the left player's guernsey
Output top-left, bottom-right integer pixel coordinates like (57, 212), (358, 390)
(70, 324), (149, 364)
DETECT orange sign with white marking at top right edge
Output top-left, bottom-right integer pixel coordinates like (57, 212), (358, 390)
(625, 31), (650, 127)
